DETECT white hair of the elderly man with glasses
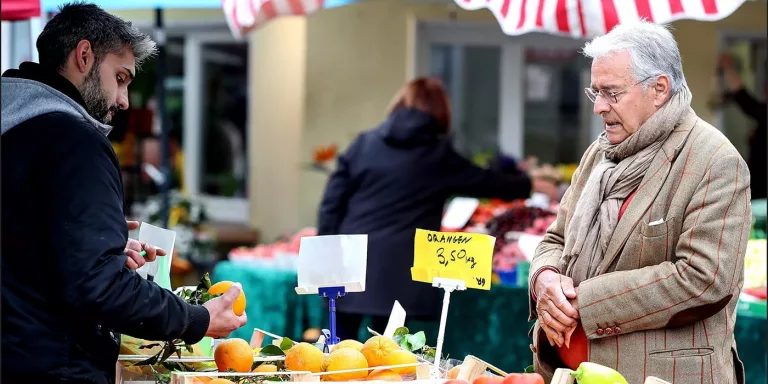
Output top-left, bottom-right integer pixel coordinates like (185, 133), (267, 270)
(582, 20), (688, 95)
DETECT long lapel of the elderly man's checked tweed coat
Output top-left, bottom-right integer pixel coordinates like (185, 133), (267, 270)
(599, 110), (698, 274)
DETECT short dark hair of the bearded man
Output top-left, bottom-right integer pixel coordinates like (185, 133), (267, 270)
(37, 2), (157, 71)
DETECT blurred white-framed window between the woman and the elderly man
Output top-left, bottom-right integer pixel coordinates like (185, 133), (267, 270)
(414, 22), (602, 164)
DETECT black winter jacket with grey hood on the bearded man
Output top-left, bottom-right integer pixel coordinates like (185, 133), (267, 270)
(0, 63), (210, 384)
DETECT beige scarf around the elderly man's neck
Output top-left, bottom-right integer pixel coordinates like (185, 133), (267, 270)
(560, 86), (691, 286)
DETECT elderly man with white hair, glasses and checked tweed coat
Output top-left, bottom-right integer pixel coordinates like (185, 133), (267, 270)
(530, 22), (751, 384)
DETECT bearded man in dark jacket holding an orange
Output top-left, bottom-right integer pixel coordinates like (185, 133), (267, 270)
(0, 3), (247, 384)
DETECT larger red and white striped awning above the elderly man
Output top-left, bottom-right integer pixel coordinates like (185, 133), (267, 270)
(455, 0), (745, 38)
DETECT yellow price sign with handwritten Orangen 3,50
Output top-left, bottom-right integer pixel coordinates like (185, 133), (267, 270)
(411, 229), (496, 290)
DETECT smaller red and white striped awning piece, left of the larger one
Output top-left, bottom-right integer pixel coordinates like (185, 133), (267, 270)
(221, 0), (325, 37)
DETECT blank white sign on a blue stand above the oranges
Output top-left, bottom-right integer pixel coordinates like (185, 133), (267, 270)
(296, 235), (368, 294)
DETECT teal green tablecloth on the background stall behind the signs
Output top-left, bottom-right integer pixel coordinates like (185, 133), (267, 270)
(213, 262), (768, 384)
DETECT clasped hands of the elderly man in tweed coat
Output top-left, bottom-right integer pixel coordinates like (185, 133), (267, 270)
(534, 270), (579, 347)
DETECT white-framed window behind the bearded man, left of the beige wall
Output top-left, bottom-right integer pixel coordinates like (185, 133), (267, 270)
(126, 26), (250, 223)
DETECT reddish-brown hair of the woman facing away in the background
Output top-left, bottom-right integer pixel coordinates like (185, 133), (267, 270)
(389, 77), (451, 134)
